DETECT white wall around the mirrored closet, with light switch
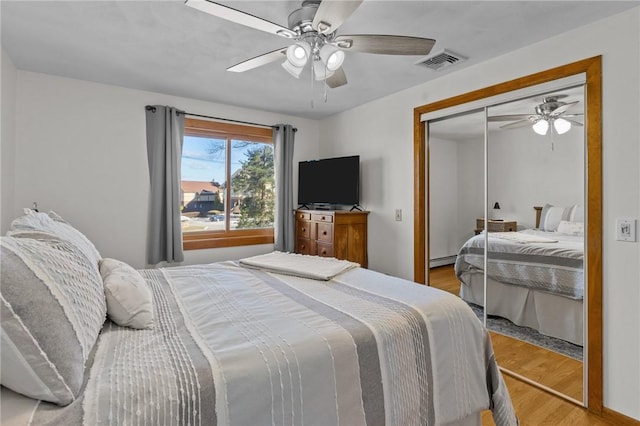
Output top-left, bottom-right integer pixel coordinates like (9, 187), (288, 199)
(320, 8), (640, 419)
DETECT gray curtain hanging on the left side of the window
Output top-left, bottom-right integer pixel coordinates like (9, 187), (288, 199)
(145, 105), (184, 265)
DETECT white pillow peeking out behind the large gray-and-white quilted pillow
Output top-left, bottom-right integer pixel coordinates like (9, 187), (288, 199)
(7, 209), (102, 265)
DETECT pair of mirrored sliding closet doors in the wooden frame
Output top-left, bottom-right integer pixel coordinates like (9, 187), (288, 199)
(416, 58), (601, 405)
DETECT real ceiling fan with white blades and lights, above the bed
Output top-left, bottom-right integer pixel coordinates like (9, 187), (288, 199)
(185, 0), (435, 88)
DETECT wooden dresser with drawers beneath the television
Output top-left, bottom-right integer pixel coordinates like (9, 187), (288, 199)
(295, 210), (369, 268)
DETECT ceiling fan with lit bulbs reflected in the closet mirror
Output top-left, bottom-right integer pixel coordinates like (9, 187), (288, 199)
(487, 95), (583, 135)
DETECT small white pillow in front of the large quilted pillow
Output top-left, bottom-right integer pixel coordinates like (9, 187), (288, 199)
(100, 258), (153, 329)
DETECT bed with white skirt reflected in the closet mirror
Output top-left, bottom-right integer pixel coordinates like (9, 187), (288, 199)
(455, 204), (584, 346)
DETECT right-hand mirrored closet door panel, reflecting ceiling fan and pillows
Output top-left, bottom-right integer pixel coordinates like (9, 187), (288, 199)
(483, 85), (585, 403)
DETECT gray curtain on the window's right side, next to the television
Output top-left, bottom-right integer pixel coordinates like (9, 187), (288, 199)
(273, 124), (297, 252)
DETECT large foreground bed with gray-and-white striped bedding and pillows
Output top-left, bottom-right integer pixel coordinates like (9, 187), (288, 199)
(0, 208), (517, 425)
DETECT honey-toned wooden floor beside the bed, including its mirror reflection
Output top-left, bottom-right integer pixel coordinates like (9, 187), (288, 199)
(429, 265), (612, 426)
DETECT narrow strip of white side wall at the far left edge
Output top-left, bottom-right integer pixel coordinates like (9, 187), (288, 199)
(0, 50), (17, 234)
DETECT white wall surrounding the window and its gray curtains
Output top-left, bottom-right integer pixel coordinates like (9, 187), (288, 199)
(8, 71), (318, 268)
